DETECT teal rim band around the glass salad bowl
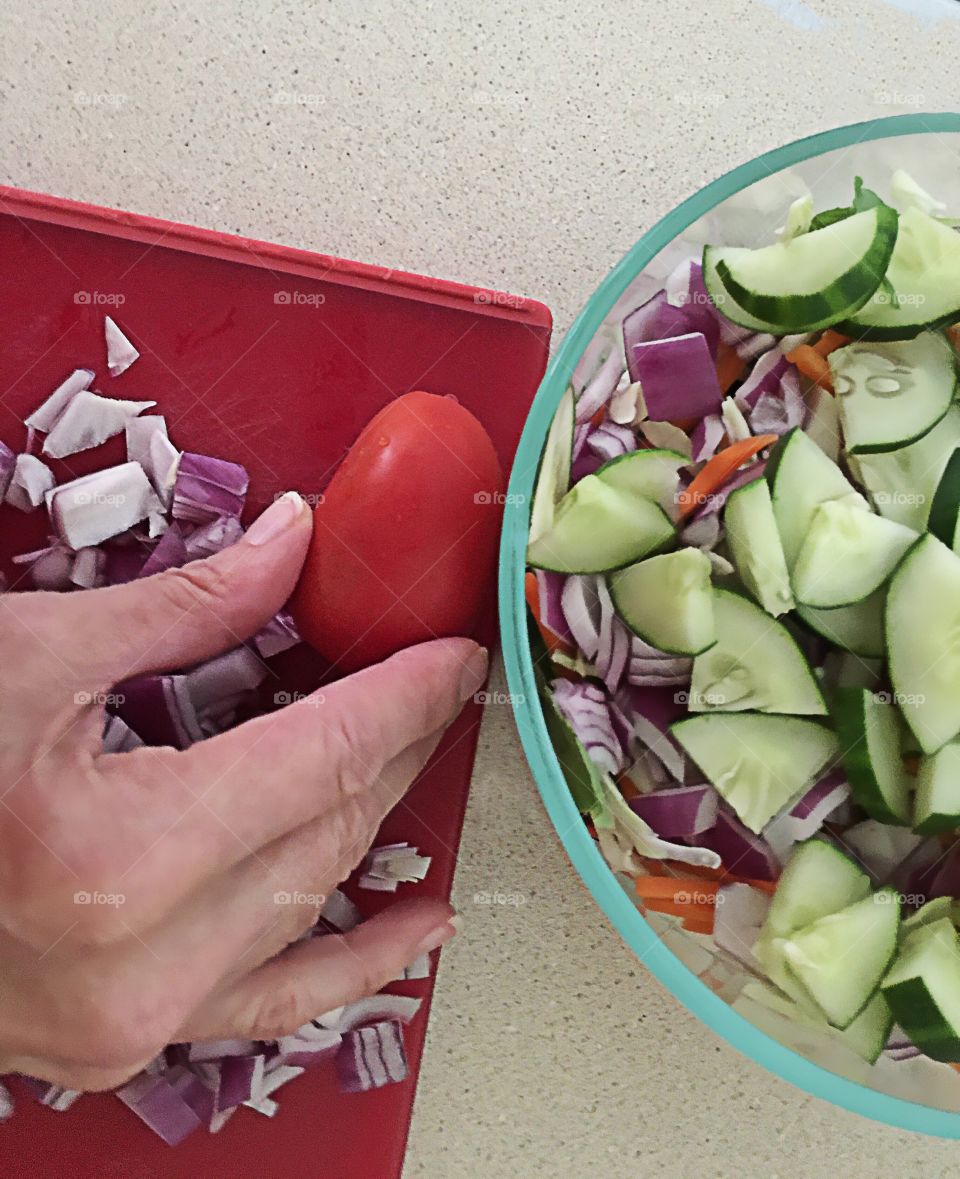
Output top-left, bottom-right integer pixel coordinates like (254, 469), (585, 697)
(499, 112), (960, 1138)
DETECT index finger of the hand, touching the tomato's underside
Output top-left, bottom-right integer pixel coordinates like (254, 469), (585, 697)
(98, 639), (487, 921)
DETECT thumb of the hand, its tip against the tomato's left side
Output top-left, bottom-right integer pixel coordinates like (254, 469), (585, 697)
(57, 492), (313, 689)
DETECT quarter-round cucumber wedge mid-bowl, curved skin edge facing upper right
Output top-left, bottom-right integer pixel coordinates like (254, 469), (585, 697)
(689, 590), (827, 717)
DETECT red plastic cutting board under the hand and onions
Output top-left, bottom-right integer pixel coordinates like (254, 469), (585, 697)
(0, 187), (551, 1179)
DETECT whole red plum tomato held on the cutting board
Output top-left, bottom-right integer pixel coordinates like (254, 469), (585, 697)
(290, 393), (502, 673)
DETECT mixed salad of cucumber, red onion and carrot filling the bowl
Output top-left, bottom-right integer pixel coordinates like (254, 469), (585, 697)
(526, 172), (960, 1067)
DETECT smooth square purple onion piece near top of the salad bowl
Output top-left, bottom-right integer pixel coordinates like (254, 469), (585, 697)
(627, 331), (723, 421)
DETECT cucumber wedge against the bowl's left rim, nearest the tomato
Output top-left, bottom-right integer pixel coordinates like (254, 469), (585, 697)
(527, 475), (675, 573)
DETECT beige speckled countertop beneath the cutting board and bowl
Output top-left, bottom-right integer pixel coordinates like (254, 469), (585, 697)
(0, 0), (960, 1179)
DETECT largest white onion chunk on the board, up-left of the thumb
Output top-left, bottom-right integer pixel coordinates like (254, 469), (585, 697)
(46, 462), (160, 549)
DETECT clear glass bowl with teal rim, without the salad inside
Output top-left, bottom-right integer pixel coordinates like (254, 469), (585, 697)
(499, 113), (960, 1138)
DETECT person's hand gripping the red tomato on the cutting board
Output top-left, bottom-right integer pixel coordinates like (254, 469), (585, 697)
(0, 495), (487, 1089)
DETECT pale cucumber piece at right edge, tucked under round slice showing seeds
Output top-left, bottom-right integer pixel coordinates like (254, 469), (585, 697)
(851, 410), (960, 532)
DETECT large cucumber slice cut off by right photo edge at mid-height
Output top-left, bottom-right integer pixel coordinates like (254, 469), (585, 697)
(885, 534), (960, 753)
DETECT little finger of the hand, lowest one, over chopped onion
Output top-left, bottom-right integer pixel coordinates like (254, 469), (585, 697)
(178, 897), (458, 1040)
